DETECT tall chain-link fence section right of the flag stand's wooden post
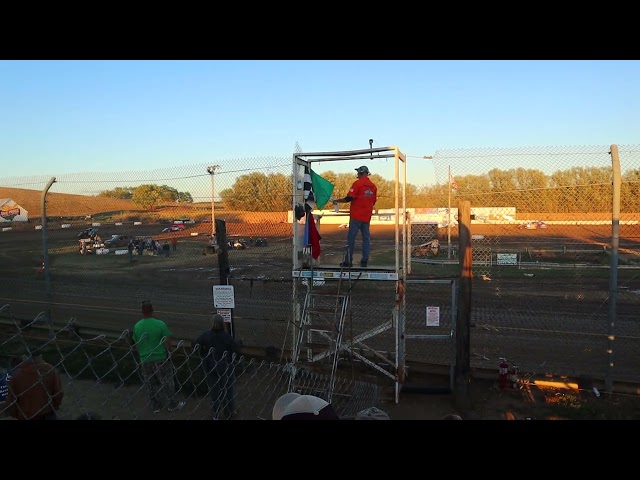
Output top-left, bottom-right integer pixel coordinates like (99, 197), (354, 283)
(413, 146), (640, 382)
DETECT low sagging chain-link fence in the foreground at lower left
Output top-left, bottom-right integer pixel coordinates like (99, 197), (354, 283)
(0, 305), (381, 420)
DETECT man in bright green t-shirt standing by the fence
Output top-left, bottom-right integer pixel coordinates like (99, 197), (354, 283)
(132, 301), (186, 413)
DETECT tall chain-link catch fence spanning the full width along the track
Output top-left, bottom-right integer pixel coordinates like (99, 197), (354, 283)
(0, 146), (640, 398)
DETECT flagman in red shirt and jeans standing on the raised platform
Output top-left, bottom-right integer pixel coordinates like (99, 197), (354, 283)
(333, 165), (378, 267)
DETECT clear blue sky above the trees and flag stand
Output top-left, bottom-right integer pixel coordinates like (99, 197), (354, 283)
(0, 60), (640, 194)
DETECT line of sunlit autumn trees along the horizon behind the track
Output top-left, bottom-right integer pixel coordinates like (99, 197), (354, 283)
(99, 167), (640, 213)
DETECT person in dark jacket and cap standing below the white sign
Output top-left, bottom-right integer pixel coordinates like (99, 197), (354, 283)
(193, 313), (240, 420)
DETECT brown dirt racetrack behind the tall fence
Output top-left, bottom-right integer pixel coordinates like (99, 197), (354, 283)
(0, 216), (640, 388)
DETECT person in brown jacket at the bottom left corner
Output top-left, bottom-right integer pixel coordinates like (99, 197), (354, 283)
(5, 352), (64, 420)
